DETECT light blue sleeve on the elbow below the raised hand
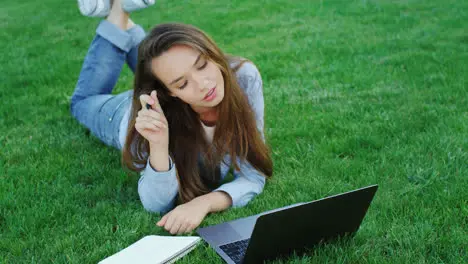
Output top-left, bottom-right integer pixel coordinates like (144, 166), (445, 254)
(138, 158), (179, 214)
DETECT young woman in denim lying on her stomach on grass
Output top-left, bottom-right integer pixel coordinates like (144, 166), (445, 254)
(71, 0), (272, 234)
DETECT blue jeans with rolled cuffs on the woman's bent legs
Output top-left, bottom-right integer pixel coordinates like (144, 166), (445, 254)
(70, 20), (146, 149)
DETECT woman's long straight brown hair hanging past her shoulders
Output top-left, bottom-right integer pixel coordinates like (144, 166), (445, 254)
(122, 23), (273, 202)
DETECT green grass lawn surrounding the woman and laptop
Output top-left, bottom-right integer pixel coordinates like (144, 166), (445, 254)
(0, 0), (468, 263)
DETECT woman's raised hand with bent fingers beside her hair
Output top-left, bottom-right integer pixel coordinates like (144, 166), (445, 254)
(135, 90), (169, 150)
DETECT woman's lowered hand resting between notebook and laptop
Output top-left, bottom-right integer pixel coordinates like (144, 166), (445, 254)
(156, 197), (210, 234)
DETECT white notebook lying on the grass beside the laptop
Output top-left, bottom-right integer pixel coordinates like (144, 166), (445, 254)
(99, 236), (201, 264)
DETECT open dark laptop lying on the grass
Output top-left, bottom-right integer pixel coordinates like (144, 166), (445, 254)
(197, 185), (377, 264)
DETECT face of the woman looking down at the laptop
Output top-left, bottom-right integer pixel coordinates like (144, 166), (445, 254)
(151, 45), (224, 113)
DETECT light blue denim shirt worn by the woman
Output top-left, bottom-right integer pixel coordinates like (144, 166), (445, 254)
(138, 62), (265, 213)
